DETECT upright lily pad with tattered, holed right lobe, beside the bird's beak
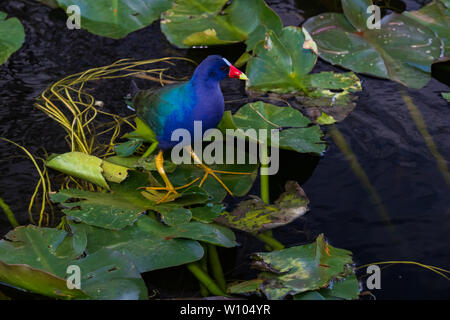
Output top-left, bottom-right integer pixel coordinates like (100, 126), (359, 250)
(246, 27), (361, 115)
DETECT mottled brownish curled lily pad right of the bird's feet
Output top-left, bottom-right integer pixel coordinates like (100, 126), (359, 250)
(215, 181), (309, 233)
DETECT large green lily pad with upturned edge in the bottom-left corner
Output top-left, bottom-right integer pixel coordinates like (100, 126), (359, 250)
(0, 225), (147, 299)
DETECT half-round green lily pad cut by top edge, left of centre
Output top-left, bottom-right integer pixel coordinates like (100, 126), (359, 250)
(56, 0), (173, 39)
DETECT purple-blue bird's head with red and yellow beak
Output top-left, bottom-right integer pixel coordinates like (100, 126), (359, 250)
(194, 55), (248, 81)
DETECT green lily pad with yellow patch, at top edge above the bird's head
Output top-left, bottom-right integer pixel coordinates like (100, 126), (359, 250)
(161, 0), (282, 48)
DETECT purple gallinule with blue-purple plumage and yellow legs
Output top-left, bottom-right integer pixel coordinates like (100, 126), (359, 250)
(133, 55), (248, 202)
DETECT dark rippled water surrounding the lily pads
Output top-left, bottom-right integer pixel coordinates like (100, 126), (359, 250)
(0, 0), (450, 299)
